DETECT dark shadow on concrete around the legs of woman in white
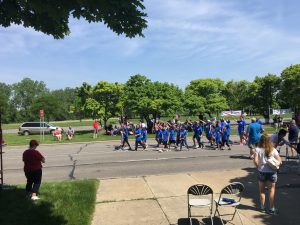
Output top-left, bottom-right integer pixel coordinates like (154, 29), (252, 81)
(230, 168), (300, 225)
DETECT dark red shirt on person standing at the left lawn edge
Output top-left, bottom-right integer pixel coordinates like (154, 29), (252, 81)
(23, 149), (44, 172)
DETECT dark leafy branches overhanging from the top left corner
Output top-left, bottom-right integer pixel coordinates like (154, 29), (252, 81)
(0, 0), (147, 39)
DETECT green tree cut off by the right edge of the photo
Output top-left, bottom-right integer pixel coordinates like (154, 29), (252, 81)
(280, 64), (300, 111)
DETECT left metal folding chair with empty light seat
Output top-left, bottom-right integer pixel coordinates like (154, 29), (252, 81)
(187, 184), (214, 225)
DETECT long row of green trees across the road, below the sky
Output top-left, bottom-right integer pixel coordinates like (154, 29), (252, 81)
(0, 64), (300, 124)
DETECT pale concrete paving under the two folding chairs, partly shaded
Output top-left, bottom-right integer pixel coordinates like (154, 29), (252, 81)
(92, 168), (300, 225)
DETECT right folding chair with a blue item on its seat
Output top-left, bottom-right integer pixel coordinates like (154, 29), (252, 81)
(214, 182), (245, 225)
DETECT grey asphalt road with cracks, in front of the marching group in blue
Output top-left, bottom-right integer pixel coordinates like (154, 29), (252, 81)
(3, 137), (253, 184)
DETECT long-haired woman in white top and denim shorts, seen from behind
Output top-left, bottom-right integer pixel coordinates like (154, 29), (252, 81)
(253, 134), (281, 215)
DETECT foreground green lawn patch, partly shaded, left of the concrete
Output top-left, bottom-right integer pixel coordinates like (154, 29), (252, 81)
(0, 180), (98, 225)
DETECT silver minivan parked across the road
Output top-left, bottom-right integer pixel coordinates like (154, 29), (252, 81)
(18, 122), (63, 135)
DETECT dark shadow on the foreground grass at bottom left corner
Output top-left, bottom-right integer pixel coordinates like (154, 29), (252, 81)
(0, 186), (67, 225)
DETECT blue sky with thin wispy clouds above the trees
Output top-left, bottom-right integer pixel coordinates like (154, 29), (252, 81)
(0, 0), (300, 90)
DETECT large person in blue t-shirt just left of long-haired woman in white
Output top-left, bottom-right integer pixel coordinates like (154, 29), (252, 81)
(246, 117), (262, 159)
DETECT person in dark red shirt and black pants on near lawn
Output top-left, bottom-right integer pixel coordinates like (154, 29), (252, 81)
(23, 140), (45, 201)
